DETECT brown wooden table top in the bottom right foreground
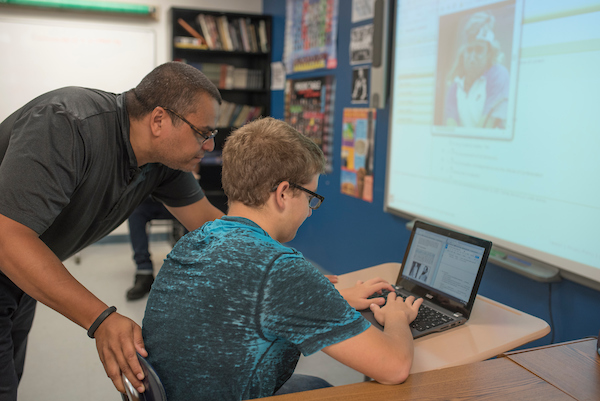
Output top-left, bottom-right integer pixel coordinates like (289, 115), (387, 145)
(265, 338), (600, 401)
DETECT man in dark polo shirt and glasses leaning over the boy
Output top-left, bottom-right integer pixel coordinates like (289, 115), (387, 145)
(0, 62), (222, 401)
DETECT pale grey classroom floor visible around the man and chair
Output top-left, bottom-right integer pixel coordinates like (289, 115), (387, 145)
(19, 236), (363, 401)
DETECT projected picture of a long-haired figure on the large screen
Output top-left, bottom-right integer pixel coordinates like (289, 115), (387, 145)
(433, 2), (520, 139)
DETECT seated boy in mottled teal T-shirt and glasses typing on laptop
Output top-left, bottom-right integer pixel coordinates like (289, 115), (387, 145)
(143, 118), (422, 401)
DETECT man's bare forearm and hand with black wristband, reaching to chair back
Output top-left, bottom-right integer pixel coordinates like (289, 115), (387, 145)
(0, 214), (148, 392)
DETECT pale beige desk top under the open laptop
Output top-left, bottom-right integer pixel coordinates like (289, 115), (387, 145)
(336, 263), (550, 373)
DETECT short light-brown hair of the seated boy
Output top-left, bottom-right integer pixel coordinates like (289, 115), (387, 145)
(222, 117), (325, 207)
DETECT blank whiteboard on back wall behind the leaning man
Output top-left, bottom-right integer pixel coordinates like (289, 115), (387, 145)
(0, 19), (156, 121)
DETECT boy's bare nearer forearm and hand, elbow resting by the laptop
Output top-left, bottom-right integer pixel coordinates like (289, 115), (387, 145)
(323, 292), (423, 384)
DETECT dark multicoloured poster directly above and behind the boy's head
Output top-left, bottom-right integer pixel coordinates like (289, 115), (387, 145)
(284, 75), (335, 173)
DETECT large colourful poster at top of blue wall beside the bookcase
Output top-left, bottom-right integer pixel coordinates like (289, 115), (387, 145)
(283, 0), (338, 74)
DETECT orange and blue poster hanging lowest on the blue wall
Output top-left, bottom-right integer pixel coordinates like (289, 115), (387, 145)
(340, 108), (377, 202)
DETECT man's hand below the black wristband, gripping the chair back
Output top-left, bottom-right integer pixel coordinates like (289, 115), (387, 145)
(94, 313), (148, 393)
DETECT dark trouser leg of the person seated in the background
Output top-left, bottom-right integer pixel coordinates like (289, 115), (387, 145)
(128, 197), (175, 273)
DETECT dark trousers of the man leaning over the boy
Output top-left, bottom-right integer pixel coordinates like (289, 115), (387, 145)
(0, 272), (37, 401)
